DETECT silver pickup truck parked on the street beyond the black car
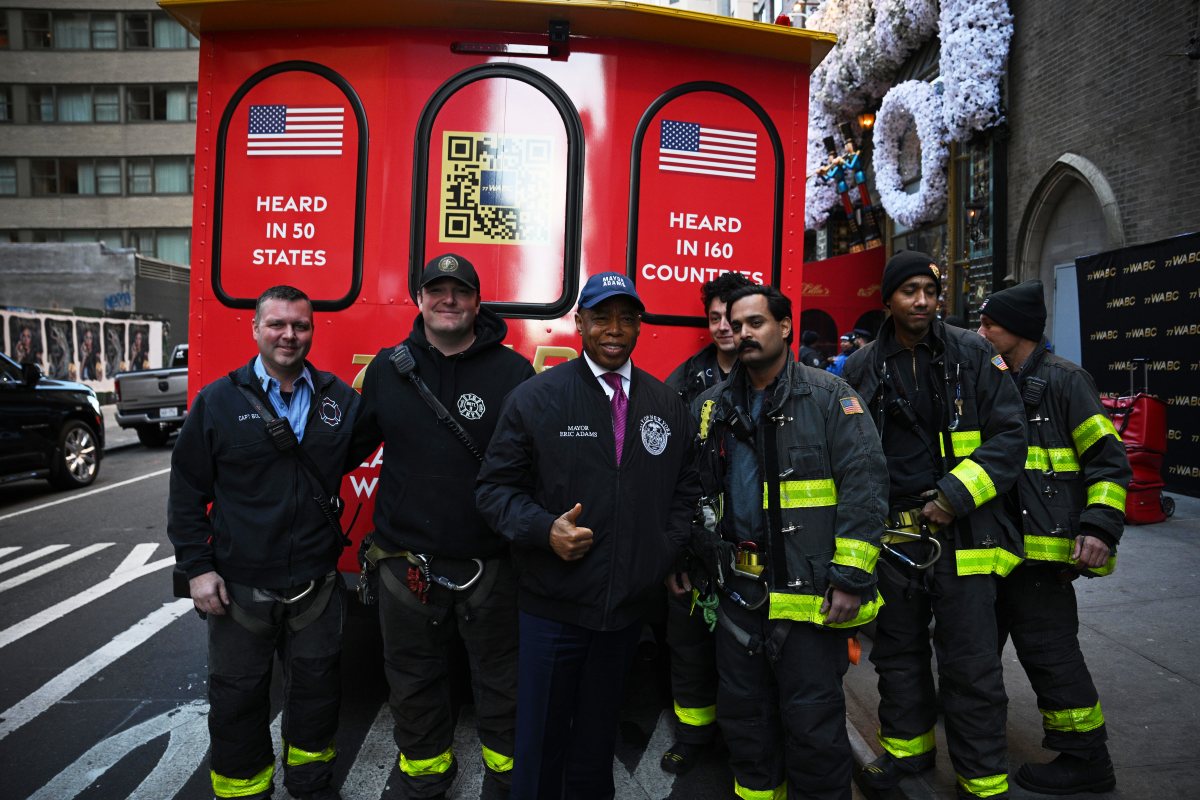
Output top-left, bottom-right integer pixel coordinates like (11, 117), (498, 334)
(113, 344), (187, 447)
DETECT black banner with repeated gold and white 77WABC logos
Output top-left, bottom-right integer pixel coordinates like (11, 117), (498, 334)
(1075, 227), (1200, 497)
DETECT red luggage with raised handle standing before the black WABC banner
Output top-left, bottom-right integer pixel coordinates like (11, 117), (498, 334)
(1100, 359), (1175, 525)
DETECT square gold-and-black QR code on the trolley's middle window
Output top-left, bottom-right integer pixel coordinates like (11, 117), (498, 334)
(440, 131), (553, 245)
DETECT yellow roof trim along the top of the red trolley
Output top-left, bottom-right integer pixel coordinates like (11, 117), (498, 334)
(158, 0), (838, 66)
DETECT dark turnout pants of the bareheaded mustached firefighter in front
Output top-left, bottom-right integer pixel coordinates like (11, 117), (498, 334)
(716, 584), (853, 800)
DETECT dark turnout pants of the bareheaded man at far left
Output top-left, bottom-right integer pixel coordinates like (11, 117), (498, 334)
(209, 575), (346, 798)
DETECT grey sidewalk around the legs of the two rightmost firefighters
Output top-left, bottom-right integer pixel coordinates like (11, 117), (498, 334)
(846, 495), (1200, 800)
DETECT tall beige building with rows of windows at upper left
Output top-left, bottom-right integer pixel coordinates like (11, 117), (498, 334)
(0, 0), (199, 266)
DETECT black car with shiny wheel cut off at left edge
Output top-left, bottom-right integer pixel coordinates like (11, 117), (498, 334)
(0, 353), (104, 489)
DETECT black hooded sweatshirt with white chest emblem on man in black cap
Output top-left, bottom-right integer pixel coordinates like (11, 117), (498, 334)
(350, 307), (534, 558)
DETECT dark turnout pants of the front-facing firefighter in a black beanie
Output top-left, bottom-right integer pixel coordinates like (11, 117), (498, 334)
(871, 542), (1008, 796)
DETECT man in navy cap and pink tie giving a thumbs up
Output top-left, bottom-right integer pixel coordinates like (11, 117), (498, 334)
(475, 272), (700, 800)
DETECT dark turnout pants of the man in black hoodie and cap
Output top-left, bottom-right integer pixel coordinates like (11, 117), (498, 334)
(379, 558), (517, 798)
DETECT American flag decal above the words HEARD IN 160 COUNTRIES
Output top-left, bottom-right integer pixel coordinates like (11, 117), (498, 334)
(659, 120), (758, 181)
